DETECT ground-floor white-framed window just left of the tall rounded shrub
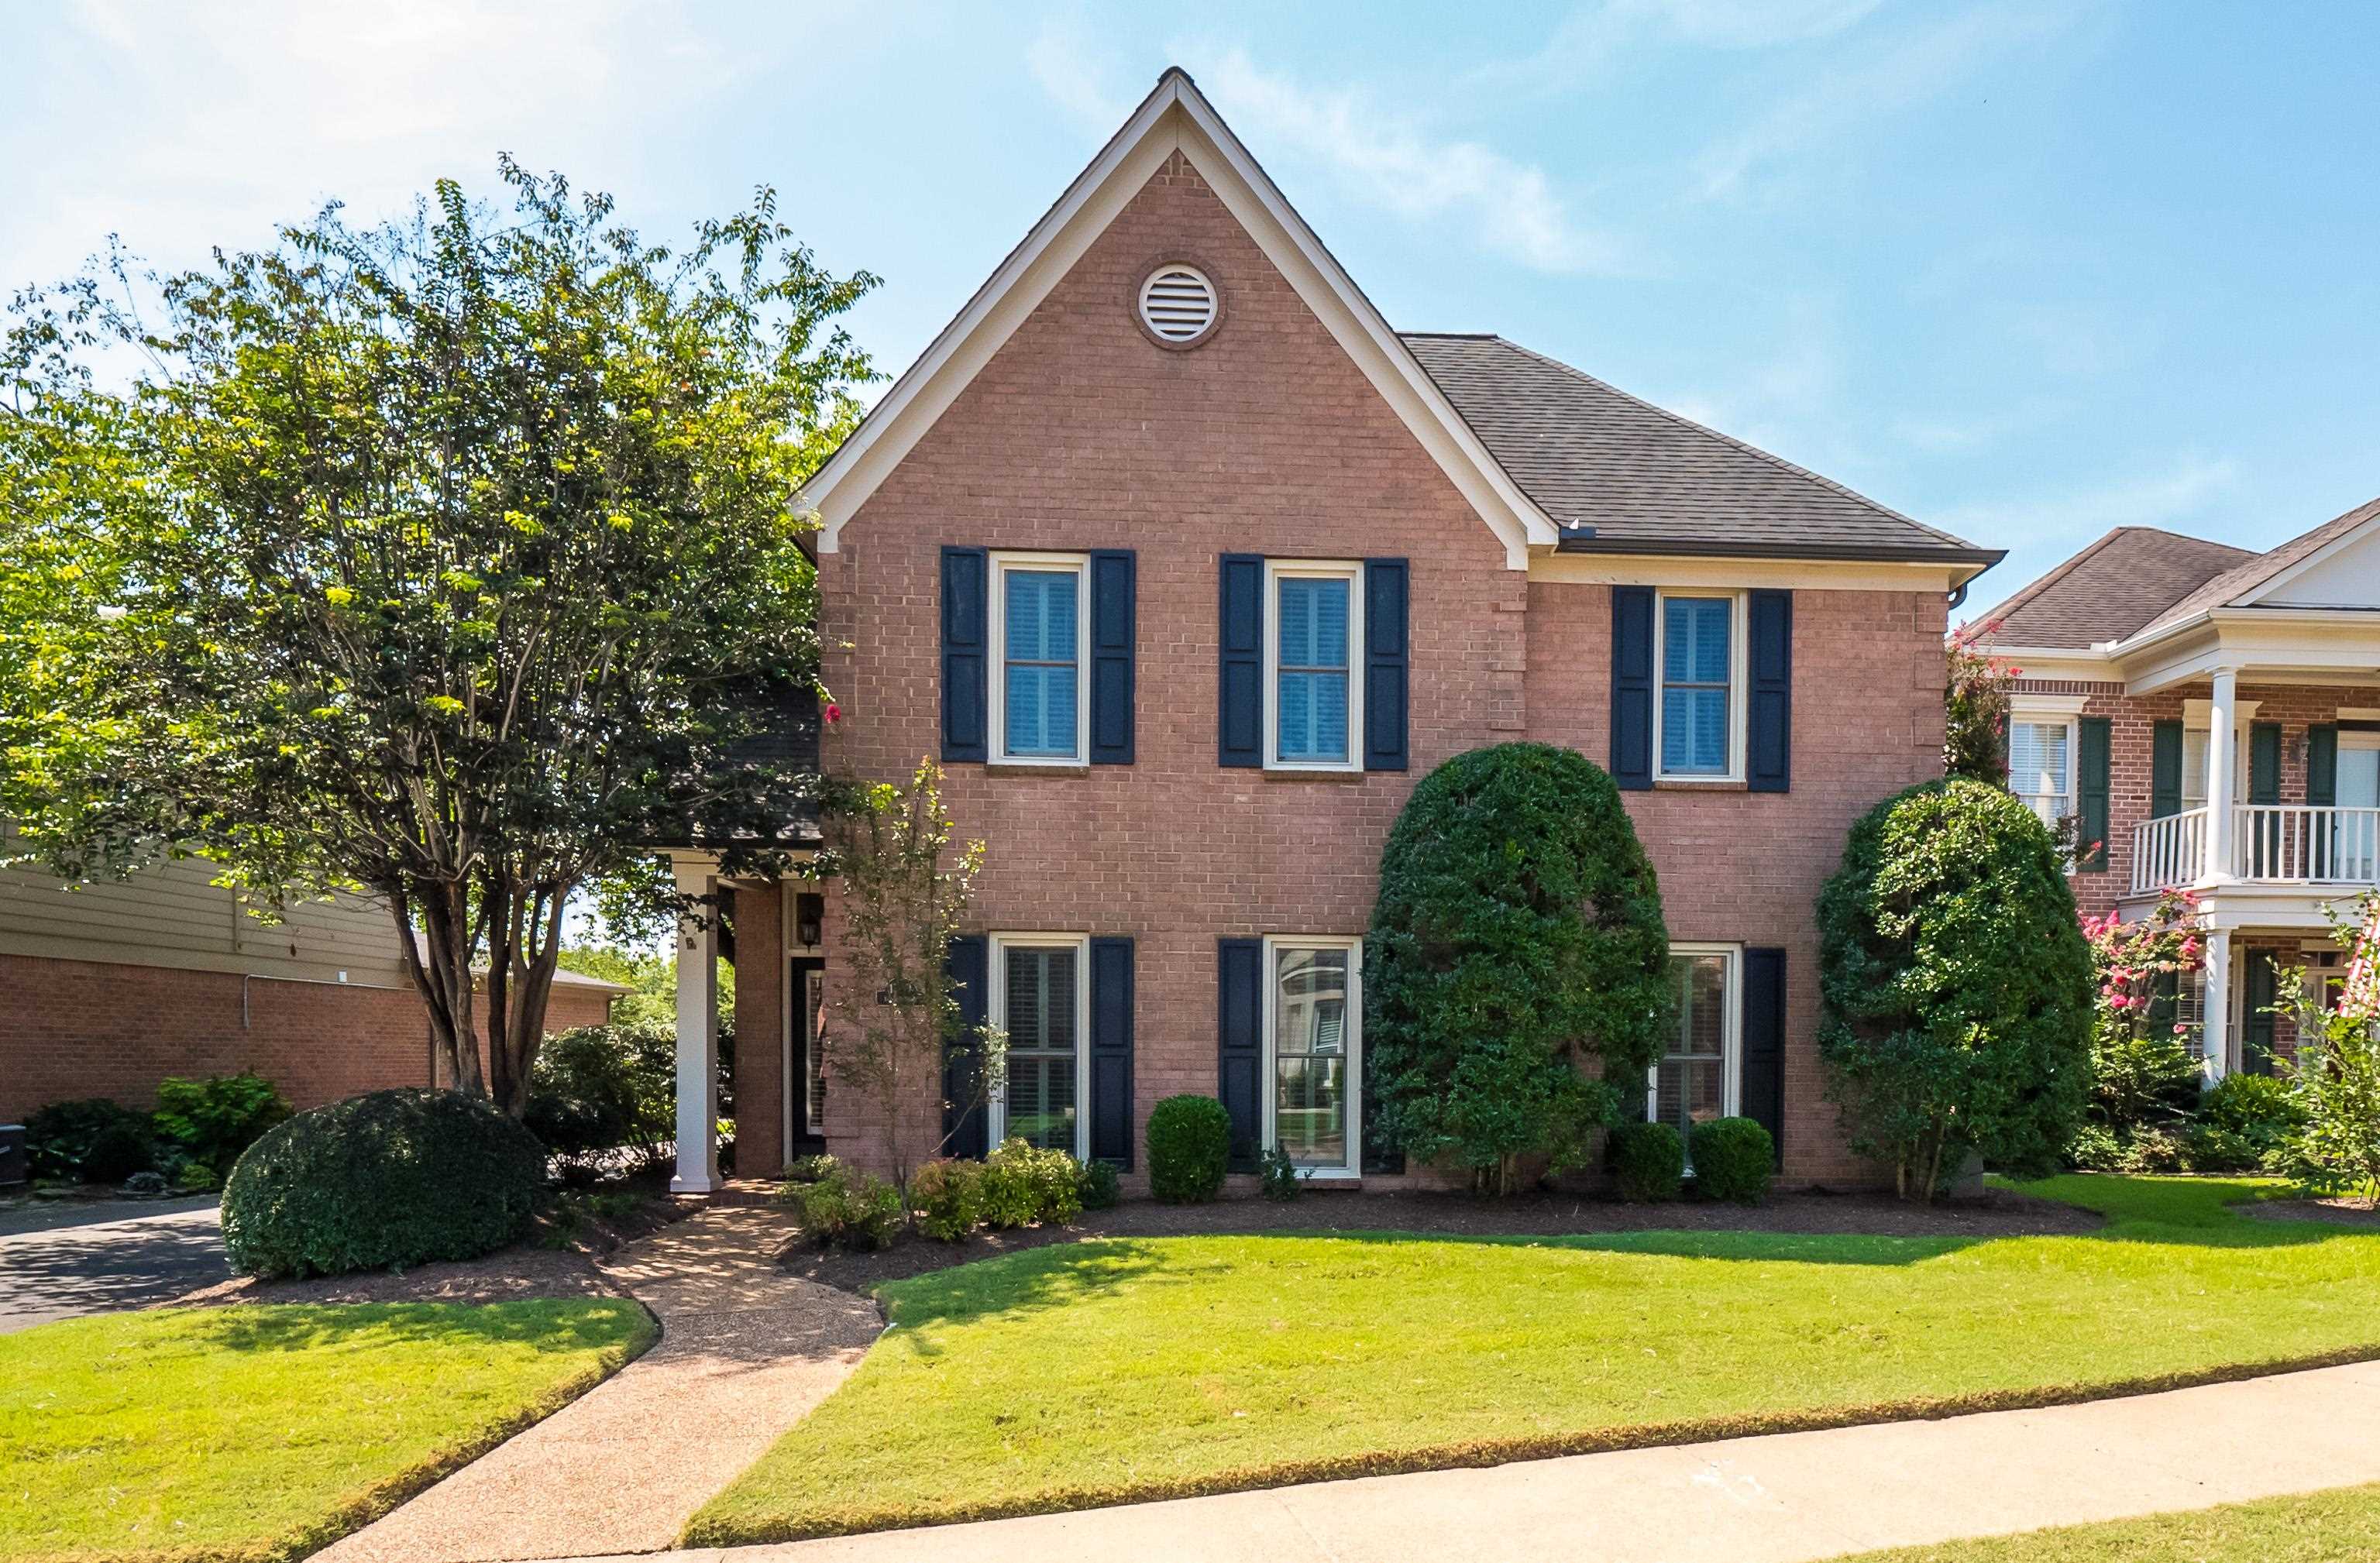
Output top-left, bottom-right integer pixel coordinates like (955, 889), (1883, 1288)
(1264, 935), (1364, 1177)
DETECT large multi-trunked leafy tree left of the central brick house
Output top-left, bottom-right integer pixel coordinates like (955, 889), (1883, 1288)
(0, 160), (875, 1113)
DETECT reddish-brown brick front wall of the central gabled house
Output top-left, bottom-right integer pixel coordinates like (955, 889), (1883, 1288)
(821, 160), (1945, 1180)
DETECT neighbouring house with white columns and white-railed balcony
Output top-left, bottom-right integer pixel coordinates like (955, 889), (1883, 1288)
(1978, 500), (2380, 1075)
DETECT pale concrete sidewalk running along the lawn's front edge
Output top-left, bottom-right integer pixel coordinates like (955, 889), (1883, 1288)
(561, 1363), (2380, 1563)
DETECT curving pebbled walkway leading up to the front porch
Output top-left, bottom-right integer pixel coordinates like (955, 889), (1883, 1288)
(317, 1206), (883, 1563)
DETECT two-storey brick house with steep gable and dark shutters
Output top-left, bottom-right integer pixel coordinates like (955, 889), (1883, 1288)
(676, 71), (1999, 1187)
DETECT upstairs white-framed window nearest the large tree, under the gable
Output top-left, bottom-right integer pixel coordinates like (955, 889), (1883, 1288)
(990, 555), (1090, 766)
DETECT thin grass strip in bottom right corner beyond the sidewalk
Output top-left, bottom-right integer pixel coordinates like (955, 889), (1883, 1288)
(1840, 1487), (2380, 1563)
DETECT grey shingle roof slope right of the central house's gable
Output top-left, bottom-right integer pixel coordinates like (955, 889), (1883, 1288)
(1399, 331), (1999, 564)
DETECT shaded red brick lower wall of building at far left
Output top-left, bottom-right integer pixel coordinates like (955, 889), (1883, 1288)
(0, 957), (609, 1123)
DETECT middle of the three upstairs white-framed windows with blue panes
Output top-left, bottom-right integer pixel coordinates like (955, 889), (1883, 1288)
(1264, 559), (1364, 771)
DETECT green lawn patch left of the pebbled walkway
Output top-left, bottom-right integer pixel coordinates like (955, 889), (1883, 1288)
(0, 1299), (652, 1563)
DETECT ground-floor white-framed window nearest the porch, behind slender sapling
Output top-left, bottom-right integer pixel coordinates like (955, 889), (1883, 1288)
(990, 933), (1090, 1159)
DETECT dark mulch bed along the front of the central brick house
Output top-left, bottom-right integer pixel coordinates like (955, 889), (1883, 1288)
(779, 1190), (2104, 1297)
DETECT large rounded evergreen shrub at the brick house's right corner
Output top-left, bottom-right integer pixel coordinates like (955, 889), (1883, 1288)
(1818, 780), (2094, 1201)
